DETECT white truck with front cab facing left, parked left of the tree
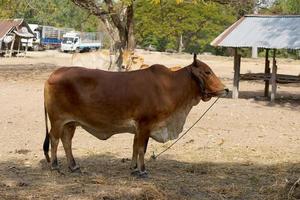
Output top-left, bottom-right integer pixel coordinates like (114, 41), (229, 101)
(60, 31), (102, 52)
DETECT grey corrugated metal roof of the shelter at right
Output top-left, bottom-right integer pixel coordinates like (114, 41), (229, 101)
(211, 15), (300, 49)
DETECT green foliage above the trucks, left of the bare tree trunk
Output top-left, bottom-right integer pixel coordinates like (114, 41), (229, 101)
(0, 0), (99, 31)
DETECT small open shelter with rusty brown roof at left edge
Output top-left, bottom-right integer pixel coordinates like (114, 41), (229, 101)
(0, 19), (34, 57)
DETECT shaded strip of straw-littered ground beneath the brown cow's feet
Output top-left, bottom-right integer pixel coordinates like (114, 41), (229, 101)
(0, 155), (300, 200)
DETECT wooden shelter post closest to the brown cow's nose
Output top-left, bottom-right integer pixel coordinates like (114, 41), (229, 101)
(232, 48), (241, 99)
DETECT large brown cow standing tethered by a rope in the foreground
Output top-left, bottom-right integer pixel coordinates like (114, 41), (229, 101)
(44, 55), (228, 177)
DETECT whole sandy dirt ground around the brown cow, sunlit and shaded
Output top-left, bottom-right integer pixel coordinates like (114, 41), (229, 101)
(0, 51), (300, 200)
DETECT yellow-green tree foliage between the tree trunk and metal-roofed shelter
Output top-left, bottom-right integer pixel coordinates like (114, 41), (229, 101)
(135, 0), (236, 52)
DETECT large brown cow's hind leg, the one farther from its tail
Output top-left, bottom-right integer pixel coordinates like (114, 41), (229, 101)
(61, 123), (80, 172)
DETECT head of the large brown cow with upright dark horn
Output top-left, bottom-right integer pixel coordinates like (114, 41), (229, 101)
(190, 54), (229, 101)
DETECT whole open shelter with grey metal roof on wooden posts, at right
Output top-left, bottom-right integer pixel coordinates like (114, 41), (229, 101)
(211, 15), (300, 101)
